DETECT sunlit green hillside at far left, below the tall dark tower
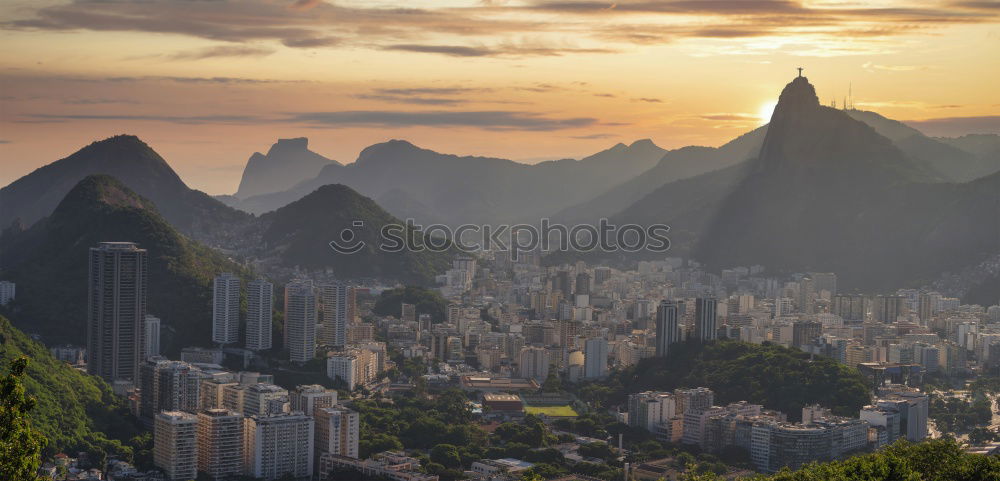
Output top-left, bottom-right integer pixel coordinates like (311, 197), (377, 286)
(0, 317), (140, 462)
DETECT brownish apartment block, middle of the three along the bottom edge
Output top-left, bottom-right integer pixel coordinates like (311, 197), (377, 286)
(198, 409), (243, 479)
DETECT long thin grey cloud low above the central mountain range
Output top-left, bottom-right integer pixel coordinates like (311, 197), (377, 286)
(288, 110), (598, 131)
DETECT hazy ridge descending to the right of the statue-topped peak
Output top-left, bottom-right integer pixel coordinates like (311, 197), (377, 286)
(844, 110), (1000, 182)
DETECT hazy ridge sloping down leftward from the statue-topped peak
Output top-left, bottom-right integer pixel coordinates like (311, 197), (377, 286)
(553, 125), (767, 223)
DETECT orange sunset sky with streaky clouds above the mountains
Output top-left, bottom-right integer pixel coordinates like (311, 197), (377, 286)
(0, 0), (1000, 194)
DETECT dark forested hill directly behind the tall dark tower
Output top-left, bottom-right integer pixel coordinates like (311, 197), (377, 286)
(0, 175), (246, 353)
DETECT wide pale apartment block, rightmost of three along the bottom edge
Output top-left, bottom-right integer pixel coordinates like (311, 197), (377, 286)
(243, 413), (315, 480)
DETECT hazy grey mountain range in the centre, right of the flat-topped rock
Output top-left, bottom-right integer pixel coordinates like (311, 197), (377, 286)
(229, 140), (665, 225)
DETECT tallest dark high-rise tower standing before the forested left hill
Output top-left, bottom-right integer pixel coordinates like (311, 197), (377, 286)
(87, 242), (148, 383)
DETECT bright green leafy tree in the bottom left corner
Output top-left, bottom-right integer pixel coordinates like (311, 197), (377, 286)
(0, 357), (46, 481)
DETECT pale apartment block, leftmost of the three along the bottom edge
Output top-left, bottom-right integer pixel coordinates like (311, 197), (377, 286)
(153, 411), (198, 481)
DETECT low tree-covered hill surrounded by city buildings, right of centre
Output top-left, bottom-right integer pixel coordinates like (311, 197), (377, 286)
(577, 341), (869, 421)
